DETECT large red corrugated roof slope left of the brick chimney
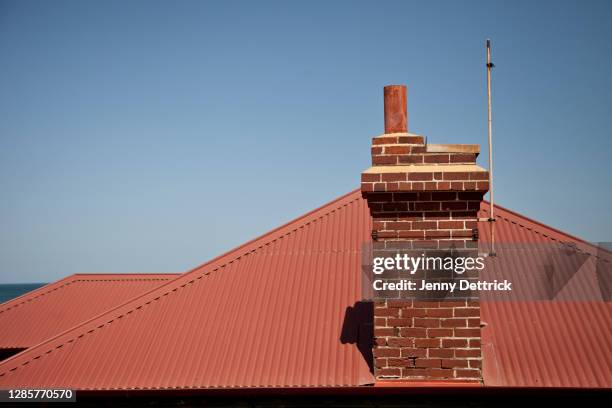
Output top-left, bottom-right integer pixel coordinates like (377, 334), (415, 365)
(0, 192), (373, 389)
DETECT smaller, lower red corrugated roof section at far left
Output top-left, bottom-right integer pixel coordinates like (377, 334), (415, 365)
(0, 273), (178, 349)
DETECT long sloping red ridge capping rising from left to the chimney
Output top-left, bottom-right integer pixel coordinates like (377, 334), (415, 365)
(0, 189), (361, 377)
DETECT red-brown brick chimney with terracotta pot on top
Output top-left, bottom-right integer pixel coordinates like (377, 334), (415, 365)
(361, 85), (489, 381)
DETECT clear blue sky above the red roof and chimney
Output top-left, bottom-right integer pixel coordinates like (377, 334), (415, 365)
(0, 1), (612, 283)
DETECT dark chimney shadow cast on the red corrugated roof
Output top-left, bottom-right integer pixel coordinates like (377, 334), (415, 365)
(340, 301), (374, 374)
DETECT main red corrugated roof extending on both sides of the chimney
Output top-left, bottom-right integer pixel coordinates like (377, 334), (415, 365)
(0, 190), (612, 390)
